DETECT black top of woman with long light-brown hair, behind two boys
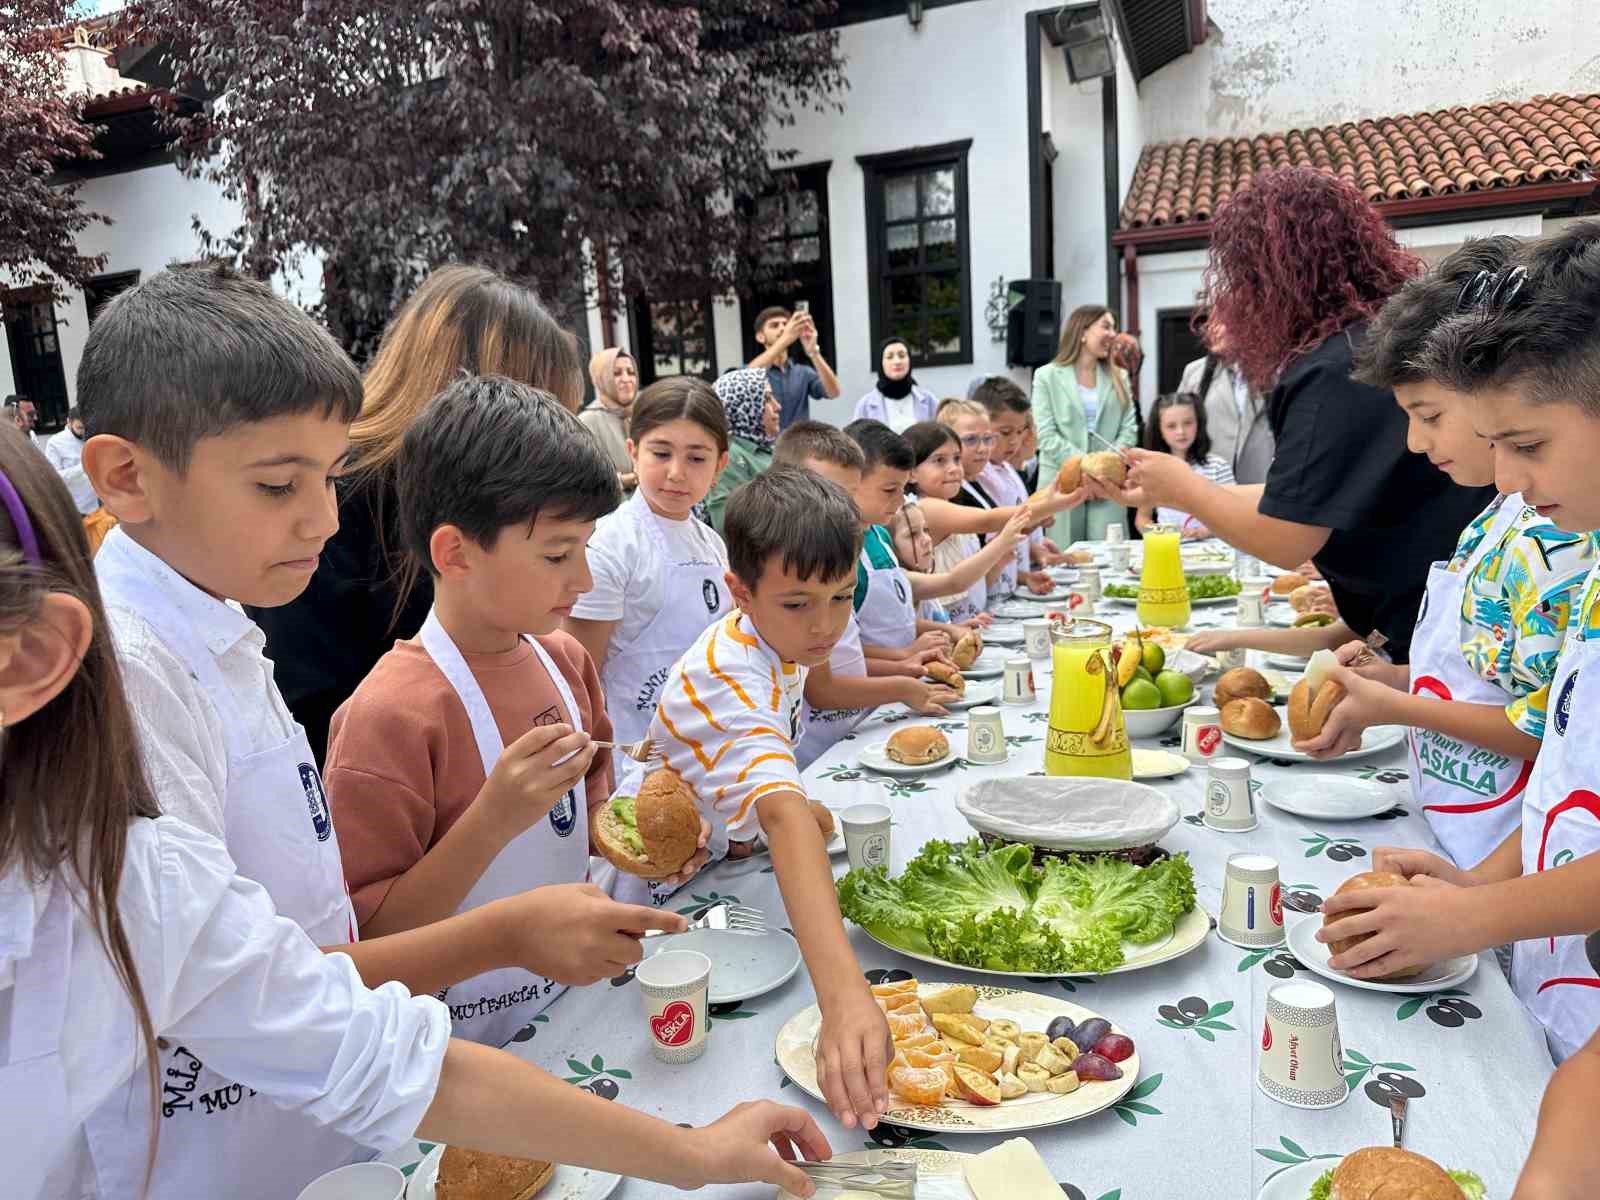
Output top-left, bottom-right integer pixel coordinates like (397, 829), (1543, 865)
(246, 480), (434, 765)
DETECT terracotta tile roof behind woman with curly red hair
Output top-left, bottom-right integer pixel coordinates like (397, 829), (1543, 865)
(1122, 93), (1600, 229)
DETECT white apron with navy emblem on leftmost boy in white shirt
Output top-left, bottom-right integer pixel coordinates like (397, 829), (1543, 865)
(86, 552), (373, 1200)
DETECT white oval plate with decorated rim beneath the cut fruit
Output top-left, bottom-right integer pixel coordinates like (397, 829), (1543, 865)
(776, 984), (1139, 1132)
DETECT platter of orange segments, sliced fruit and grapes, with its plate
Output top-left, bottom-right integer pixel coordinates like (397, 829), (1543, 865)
(776, 979), (1139, 1133)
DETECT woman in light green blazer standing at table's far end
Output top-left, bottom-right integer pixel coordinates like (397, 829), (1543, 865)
(1034, 304), (1138, 549)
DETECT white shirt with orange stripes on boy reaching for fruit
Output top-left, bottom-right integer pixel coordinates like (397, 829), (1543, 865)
(650, 611), (806, 842)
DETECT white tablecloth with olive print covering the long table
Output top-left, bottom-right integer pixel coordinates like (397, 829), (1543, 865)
(377, 585), (1550, 1200)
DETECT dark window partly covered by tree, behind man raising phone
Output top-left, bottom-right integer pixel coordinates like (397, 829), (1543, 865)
(739, 163), (834, 362)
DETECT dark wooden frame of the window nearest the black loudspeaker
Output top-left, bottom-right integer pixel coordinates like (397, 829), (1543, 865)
(856, 138), (973, 371)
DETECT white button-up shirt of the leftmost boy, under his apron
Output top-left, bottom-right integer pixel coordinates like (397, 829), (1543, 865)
(96, 526), (294, 842)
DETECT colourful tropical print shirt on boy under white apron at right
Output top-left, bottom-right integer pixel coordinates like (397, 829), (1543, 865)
(1448, 496), (1600, 738)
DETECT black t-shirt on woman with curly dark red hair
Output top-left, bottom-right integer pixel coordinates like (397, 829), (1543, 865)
(1259, 322), (1494, 662)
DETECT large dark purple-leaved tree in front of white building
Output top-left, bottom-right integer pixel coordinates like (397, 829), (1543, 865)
(142, 0), (845, 355)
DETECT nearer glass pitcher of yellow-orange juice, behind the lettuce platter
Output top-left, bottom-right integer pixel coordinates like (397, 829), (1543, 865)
(1045, 621), (1133, 779)
